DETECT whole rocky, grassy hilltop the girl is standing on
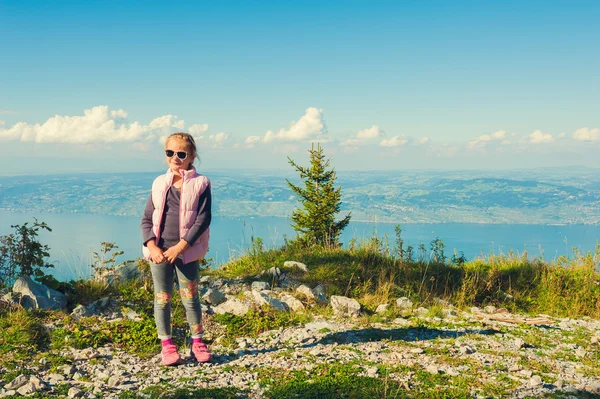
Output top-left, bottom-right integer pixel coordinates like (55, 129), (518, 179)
(0, 240), (600, 399)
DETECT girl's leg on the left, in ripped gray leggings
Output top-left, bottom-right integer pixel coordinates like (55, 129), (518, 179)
(150, 262), (174, 340)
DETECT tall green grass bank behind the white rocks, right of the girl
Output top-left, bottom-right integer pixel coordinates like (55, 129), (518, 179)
(213, 241), (600, 319)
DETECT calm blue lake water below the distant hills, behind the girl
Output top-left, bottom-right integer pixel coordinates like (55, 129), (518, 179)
(0, 211), (600, 280)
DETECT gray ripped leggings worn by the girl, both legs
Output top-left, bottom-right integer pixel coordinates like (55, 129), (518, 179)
(150, 258), (203, 339)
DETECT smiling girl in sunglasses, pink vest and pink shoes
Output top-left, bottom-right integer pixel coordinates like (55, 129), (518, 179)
(141, 133), (212, 366)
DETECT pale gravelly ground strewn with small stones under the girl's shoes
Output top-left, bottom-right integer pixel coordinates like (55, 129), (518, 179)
(0, 309), (600, 398)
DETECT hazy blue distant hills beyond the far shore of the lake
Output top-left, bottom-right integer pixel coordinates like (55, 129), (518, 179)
(0, 168), (600, 224)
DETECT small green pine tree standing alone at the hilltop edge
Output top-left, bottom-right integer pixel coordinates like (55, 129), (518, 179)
(286, 144), (350, 246)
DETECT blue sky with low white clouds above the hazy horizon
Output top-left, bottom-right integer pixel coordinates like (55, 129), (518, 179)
(0, 0), (600, 174)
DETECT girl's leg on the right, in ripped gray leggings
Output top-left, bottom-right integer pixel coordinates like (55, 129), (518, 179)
(175, 259), (204, 338)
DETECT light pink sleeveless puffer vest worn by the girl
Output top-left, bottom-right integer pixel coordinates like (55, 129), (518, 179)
(142, 166), (210, 263)
